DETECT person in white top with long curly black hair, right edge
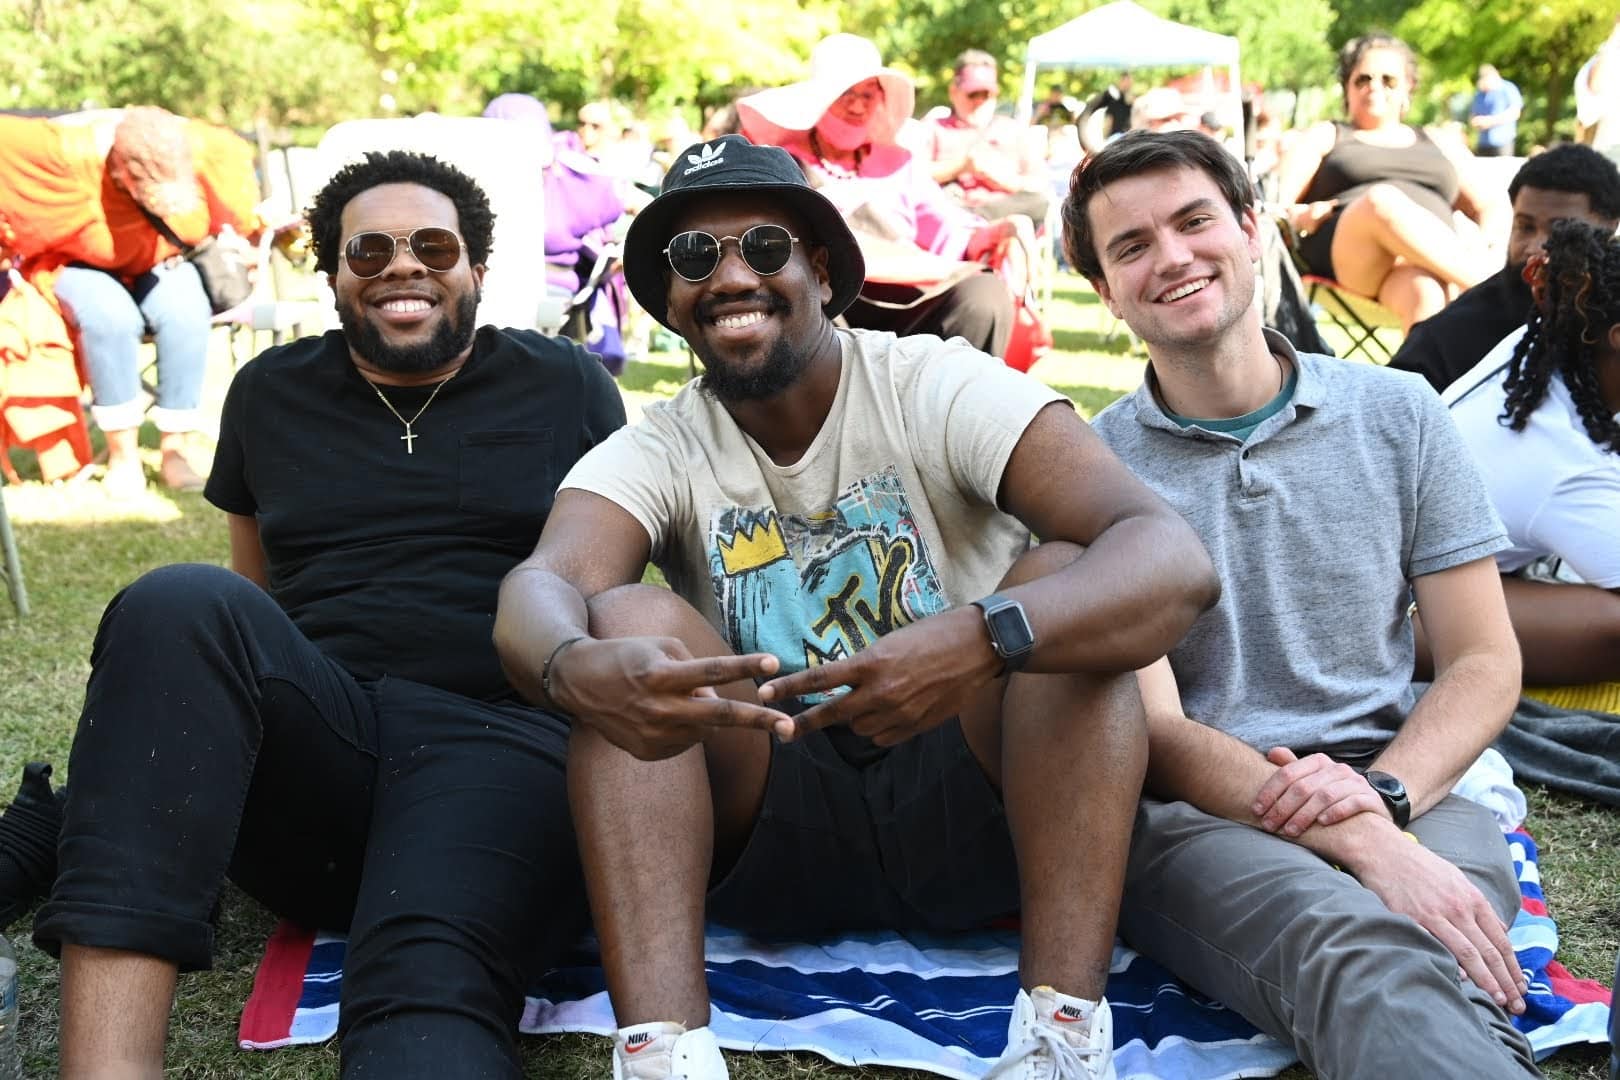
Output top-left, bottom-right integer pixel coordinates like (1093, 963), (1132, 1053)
(1445, 220), (1620, 689)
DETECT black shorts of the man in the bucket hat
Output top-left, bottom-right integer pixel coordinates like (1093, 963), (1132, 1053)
(708, 717), (1019, 936)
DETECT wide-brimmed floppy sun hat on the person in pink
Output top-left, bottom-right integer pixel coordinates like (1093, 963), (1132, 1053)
(737, 34), (917, 146)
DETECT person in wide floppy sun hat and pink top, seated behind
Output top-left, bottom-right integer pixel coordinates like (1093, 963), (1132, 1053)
(737, 34), (1017, 356)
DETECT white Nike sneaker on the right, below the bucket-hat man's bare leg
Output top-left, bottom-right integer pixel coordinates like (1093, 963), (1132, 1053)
(985, 986), (1115, 1080)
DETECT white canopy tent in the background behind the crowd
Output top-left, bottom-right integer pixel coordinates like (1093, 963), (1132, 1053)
(1017, 0), (1243, 131)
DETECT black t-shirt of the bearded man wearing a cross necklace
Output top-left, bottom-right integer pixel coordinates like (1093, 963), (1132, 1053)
(206, 327), (624, 699)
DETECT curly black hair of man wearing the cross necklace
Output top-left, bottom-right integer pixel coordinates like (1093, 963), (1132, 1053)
(305, 151), (496, 274)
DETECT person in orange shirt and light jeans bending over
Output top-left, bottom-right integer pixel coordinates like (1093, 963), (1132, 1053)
(0, 107), (259, 495)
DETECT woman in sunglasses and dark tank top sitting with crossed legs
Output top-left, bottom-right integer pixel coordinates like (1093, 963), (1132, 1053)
(1277, 34), (1507, 329)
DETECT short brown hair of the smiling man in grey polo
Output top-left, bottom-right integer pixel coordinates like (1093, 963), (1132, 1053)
(1063, 131), (1254, 280)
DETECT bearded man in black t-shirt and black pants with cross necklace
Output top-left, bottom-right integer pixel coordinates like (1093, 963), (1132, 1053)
(34, 152), (624, 1078)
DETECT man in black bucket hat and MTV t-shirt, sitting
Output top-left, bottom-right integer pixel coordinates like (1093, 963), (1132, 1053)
(496, 136), (1215, 1080)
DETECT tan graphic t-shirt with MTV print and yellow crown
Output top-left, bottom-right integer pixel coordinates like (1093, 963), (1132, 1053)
(562, 330), (1064, 689)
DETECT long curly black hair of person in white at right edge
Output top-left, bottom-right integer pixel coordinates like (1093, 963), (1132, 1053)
(1499, 219), (1620, 453)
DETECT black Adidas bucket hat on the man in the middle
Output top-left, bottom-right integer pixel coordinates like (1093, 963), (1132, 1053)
(624, 134), (867, 330)
